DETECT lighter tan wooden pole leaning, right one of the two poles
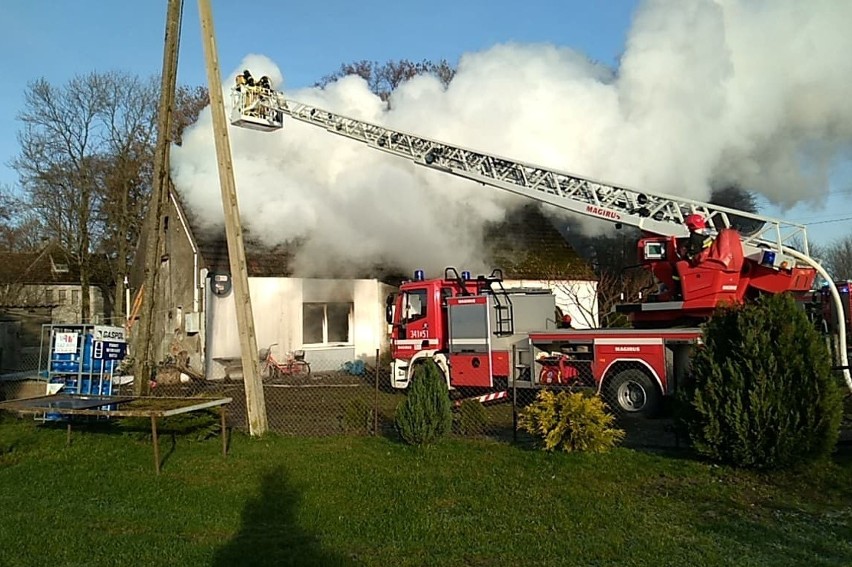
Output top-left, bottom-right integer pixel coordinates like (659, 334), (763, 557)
(198, 0), (268, 435)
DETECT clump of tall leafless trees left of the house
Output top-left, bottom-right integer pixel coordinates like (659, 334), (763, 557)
(11, 72), (209, 321)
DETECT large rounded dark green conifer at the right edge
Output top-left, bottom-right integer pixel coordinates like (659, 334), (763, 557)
(680, 294), (842, 469)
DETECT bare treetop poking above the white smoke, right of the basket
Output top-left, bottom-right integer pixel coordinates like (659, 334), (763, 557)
(314, 59), (456, 101)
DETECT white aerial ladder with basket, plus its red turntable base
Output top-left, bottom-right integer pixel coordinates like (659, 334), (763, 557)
(231, 79), (852, 390)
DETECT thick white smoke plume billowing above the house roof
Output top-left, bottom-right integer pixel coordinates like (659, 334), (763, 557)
(172, 0), (852, 275)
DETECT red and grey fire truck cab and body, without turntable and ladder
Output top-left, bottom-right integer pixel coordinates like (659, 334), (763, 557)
(388, 268), (701, 413)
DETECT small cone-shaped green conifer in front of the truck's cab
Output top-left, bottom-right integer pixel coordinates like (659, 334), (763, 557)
(396, 359), (453, 447)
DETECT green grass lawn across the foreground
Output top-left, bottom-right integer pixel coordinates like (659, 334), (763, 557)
(0, 412), (852, 567)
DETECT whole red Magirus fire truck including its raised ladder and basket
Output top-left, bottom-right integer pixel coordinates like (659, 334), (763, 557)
(231, 80), (852, 414)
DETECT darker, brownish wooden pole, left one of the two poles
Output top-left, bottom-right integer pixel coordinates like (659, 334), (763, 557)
(133, 0), (183, 396)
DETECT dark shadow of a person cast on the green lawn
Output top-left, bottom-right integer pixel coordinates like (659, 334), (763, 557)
(213, 467), (354, 567)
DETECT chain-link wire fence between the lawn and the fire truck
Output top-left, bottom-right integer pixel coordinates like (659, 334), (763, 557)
(141, 349), (679, 448)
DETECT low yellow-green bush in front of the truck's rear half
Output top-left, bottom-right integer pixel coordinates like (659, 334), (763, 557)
(518, 390), (624, 453)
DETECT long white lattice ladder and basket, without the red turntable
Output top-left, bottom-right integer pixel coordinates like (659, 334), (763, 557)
(231, 87), (809, 267)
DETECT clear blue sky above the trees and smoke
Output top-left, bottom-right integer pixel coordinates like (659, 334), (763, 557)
(0, 0), (852, 246)
